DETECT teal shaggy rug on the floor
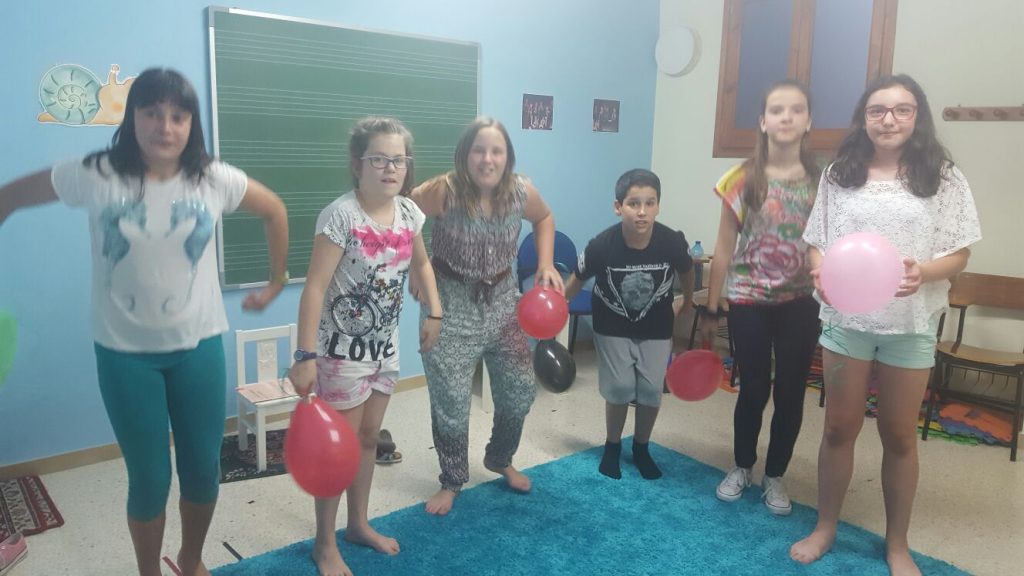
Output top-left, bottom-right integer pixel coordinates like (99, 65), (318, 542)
(213, 436), (967, 576)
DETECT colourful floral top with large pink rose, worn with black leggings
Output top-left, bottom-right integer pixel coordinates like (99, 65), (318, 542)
(715, 165), (817, 304)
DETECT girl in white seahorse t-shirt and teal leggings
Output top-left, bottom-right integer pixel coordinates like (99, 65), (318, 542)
(0, 69), (288, 576)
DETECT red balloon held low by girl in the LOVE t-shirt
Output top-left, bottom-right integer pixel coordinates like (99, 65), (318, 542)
(285, 397), (360, 498)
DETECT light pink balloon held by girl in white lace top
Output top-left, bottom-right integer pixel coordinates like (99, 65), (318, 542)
(820, 232), (903, 314)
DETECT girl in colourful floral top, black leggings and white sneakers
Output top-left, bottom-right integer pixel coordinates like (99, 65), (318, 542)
(701, 81), (820, 516)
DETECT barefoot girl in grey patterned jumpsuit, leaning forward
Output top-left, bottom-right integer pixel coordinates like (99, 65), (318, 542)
(410, 118), (563, 515)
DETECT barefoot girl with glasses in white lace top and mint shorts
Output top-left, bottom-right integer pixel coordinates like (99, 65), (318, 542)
(790, 75), (981, 575)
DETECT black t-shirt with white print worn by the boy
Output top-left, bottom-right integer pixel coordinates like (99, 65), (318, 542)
(574, 218), (693, 340)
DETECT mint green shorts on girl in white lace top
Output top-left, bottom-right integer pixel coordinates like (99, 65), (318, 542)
(818, 322), (938, 370)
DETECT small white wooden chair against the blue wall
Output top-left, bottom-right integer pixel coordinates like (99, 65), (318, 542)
(234, 324), (299, 471)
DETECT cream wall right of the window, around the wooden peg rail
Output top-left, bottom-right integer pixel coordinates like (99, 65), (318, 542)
(893, 0), (1024, 351)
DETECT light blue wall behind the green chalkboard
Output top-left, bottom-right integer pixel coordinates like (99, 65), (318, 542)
(0, 0), (658, 465)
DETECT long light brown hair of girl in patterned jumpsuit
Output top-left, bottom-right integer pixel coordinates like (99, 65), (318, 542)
(447, 116), (515, 217)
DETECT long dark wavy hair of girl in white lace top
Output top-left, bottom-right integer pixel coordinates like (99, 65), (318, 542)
(828, 74), (953, 198)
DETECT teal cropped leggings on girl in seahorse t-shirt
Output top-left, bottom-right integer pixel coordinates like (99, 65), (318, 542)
(95, 335), (226, 522)
